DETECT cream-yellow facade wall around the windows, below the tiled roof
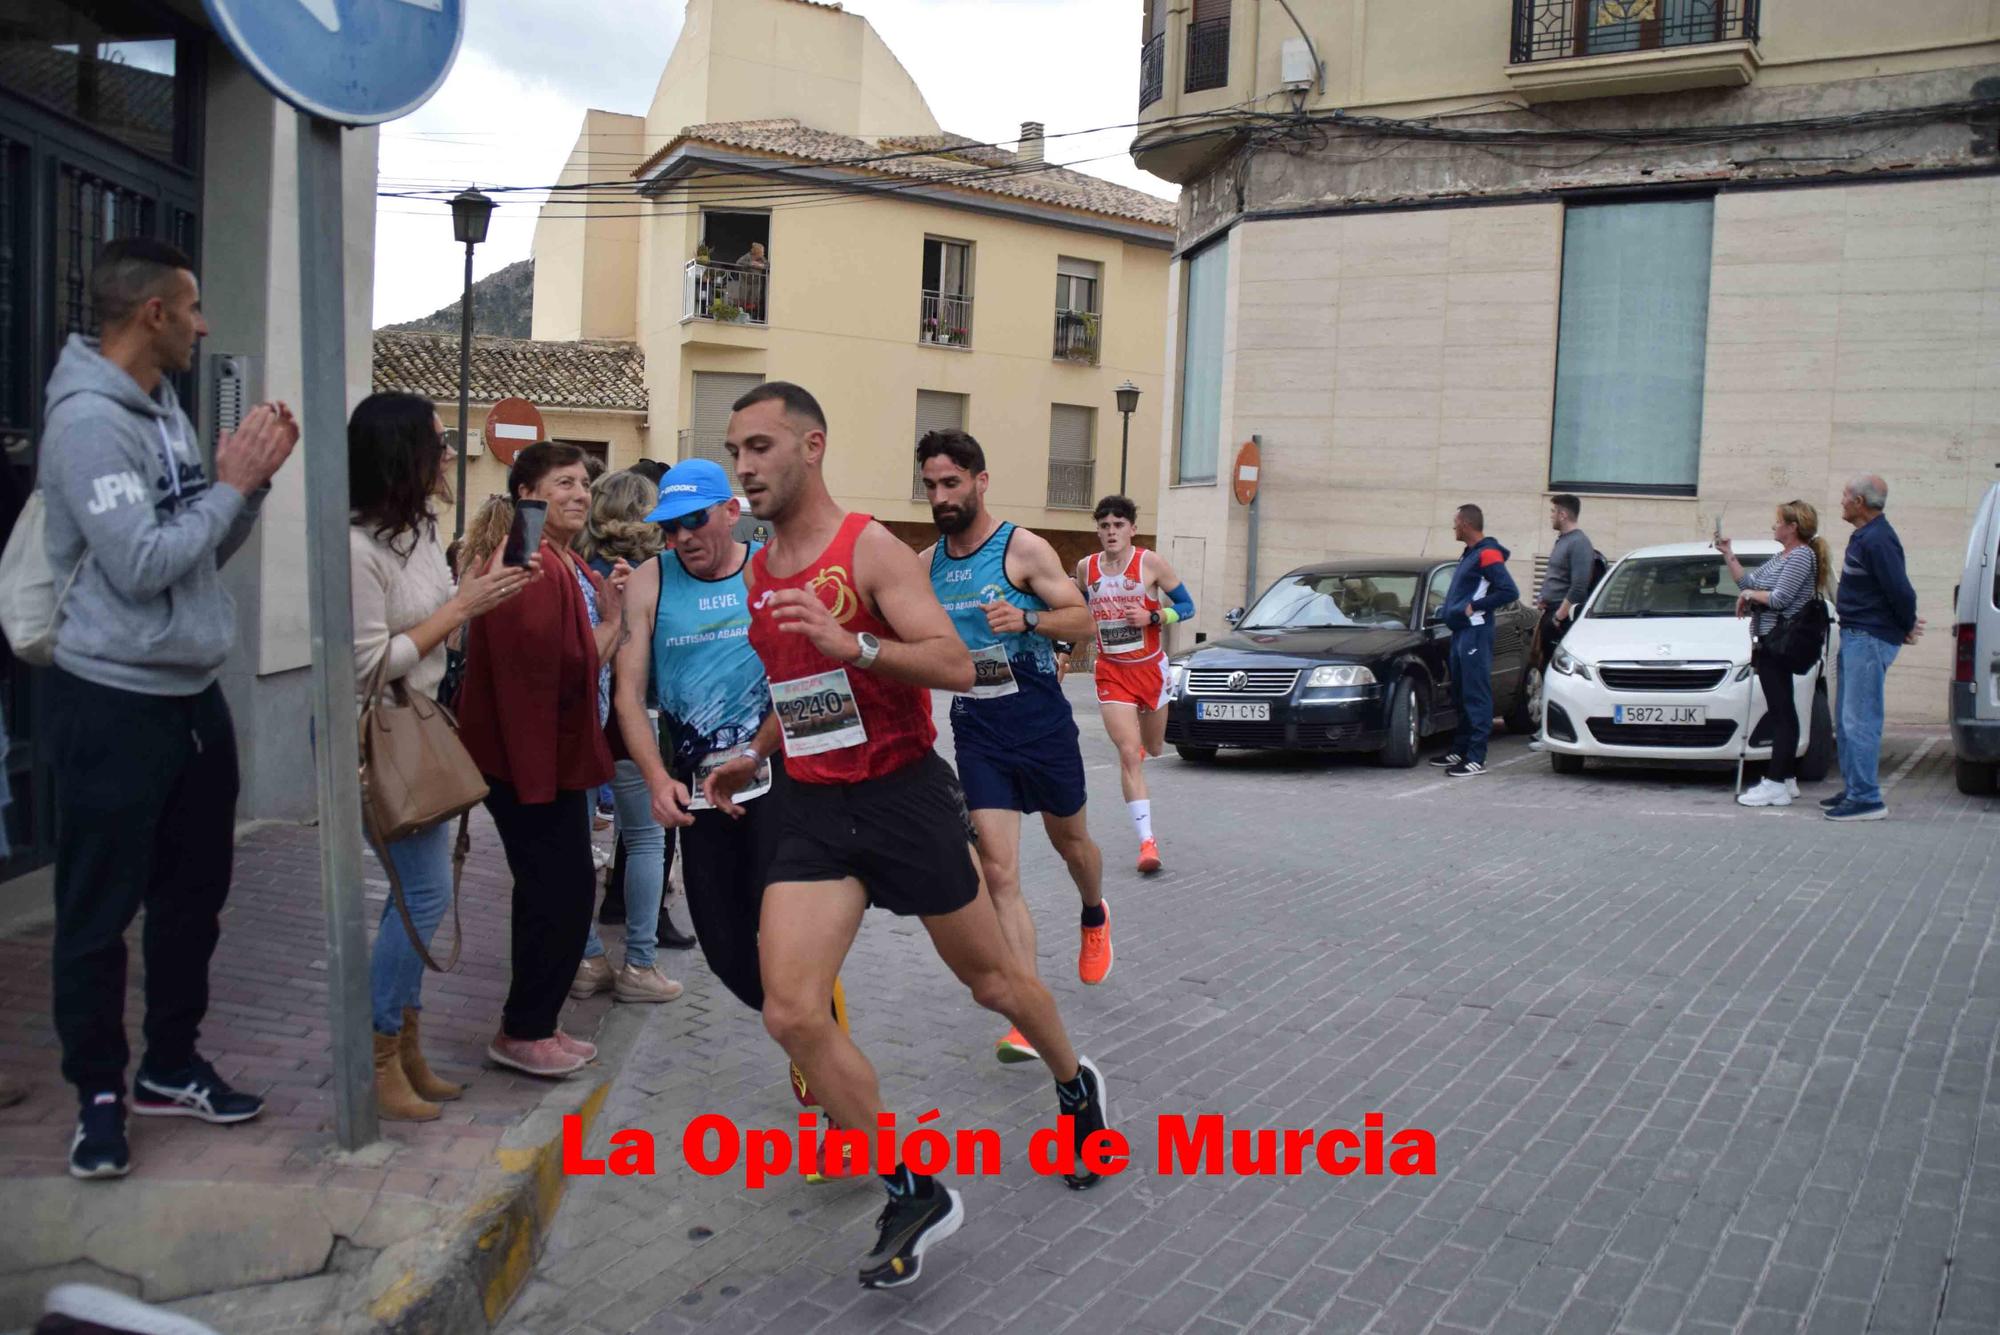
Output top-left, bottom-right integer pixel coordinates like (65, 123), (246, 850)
(640, 178), (1168, 530)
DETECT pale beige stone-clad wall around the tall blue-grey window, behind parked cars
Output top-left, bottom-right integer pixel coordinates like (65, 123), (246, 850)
(1162, 178), (2000, 721)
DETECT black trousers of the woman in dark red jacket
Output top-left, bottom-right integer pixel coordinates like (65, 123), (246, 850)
(486, 775), (598, 1041)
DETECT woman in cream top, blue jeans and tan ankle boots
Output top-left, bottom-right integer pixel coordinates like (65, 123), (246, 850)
(348, 394), (530, 1121)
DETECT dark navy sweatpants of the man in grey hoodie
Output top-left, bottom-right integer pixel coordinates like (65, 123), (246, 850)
(48, 668), (238, 1103)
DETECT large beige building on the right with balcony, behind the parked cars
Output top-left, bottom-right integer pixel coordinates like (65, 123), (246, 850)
(1134, 0), (2000, 721)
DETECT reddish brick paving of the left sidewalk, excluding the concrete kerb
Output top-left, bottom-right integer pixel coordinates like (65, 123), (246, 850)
(0, 813), (632, 1203)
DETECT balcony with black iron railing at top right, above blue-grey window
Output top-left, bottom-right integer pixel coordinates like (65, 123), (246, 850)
(1508, 0), (1760, 102)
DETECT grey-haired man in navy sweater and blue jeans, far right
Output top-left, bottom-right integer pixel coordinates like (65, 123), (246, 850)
(1820, 478), (1924, 821)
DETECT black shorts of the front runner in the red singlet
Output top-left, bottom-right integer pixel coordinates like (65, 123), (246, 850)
(766, 751), (980, 917)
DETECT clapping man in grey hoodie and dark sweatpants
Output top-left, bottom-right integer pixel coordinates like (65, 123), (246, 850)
(40, 240), (298, 1177)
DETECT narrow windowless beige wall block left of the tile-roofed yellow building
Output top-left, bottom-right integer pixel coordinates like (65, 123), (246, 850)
(532, 110), (646, 342)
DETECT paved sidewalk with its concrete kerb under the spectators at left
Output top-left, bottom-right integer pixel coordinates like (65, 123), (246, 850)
(0, 813), (664, 1335)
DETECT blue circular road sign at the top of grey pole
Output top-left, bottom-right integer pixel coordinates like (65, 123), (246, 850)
(202, 0), (466, 126)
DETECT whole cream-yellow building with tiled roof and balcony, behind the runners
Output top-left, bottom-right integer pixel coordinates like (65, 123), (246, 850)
(516, 0), (1174, 554)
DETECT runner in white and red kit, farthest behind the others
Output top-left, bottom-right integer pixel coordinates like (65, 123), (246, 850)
(1076, 496), (1194, 875)
